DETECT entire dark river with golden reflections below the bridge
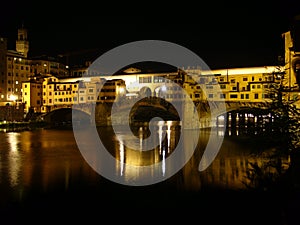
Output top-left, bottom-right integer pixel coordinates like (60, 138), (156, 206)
(0, 125), (300, 224)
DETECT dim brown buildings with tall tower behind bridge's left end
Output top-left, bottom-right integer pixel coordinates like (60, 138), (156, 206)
(0, 27), (69, 107)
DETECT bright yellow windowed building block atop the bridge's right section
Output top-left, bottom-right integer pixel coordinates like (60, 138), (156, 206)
(184, 66), (282, 102)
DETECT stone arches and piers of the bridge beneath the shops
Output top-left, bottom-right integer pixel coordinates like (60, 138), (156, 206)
(44, 100), (267, 129)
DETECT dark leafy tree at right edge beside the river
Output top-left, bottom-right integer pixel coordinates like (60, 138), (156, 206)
(245, 72), (300, 191)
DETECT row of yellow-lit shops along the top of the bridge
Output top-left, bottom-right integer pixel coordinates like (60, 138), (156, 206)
(17, 64), (299, 113)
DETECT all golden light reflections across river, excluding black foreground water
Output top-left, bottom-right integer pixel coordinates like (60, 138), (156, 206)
(0, 125), (276, 206)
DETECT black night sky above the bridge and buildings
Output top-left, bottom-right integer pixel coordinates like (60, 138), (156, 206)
(0, 0), (300, 69)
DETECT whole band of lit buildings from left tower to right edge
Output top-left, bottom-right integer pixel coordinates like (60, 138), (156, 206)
(0, 27), (300, 118)
